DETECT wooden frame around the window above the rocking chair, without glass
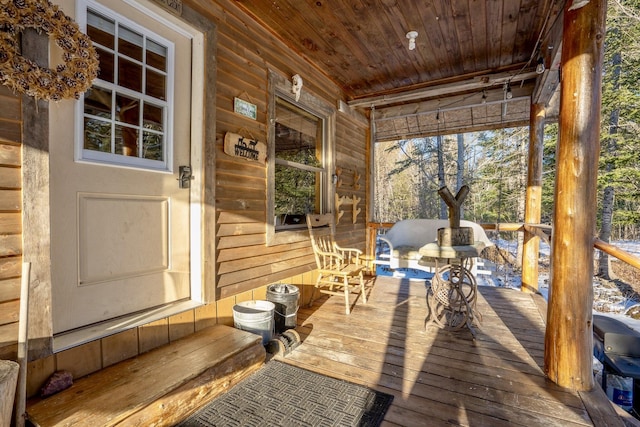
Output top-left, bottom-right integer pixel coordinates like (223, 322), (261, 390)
(266, 70), (336, 246)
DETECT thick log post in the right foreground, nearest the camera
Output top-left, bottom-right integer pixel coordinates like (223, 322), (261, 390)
(544, 0), (607, 391)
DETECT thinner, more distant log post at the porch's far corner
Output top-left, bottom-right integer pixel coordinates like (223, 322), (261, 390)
(522, 104), (545, 292)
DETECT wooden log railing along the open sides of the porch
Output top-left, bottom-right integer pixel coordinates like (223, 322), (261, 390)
(367, 222), (640, 269)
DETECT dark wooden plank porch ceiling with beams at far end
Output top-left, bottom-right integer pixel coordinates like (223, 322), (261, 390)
(237, 0), (565, 140)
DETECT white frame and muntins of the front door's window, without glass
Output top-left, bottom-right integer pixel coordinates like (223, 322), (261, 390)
(74, 0), (175, 173)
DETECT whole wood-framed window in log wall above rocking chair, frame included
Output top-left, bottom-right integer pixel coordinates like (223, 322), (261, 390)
(266, 70), (336, 246)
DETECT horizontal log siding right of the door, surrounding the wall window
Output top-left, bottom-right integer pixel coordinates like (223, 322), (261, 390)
(185, 0), (366, 300)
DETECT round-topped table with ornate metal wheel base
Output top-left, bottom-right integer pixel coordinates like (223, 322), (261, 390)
(420, 243), (484, 339)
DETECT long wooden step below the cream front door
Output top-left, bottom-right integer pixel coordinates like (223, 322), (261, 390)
(27, 325), (266, 427)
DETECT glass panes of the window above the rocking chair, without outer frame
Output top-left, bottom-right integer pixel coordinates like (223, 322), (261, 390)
(274, 98), (324, 230)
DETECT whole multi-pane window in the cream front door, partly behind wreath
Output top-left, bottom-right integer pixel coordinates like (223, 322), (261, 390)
(80, 6), (173, 170)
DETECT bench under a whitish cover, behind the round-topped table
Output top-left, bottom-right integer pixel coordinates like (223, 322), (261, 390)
(380, 219), (493, 274)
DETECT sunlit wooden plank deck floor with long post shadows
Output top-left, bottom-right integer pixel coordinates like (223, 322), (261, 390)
(279, 277), (624, 427)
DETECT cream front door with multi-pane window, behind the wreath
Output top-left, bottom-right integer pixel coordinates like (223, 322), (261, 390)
(50, 0), (198, 333)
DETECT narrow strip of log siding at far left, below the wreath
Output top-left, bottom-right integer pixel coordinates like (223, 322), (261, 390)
(0, 85), (22, 359)
